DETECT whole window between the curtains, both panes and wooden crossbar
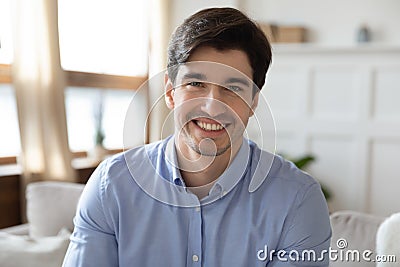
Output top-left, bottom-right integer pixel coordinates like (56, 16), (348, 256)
(58, 0), (149, 152)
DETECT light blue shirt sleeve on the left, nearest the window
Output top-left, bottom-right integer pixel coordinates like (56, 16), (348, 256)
(63, 163), (118, 267)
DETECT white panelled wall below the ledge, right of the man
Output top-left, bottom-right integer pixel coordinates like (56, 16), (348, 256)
(260, 46), (400, 216)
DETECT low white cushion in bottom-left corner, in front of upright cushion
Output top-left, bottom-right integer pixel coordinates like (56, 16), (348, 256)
(0, 229), (71, 267)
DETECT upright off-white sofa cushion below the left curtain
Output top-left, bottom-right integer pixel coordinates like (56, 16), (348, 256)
(26, 182), (84, 237)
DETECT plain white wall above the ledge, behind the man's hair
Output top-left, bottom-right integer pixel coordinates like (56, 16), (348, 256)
(169, 0), (400, 46)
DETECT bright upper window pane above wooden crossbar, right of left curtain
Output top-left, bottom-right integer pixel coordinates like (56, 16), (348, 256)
(58, 0), (149, 76)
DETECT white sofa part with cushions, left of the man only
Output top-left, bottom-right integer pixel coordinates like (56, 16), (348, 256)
(0, 182), (84, 267)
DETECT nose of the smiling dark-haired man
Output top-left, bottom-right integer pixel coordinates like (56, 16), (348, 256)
(201, 84), (227, 117)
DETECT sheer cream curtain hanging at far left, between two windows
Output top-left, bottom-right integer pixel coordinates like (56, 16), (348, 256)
(12, 0), (76, 185)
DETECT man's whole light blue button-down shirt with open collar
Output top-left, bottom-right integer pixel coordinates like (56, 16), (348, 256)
(64, 137), (331, 267)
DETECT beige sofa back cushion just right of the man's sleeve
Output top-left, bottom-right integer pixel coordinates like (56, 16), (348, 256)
(329, 211), (384, 267)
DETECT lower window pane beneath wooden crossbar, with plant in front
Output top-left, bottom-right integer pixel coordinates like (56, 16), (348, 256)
(65, 87), (147, 152)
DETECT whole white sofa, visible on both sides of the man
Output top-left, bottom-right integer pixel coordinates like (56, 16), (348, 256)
(0, 182), (400, 267)
